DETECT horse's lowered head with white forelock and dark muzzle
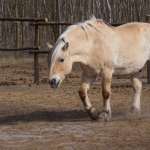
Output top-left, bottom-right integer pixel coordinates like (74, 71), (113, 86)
(47, 38), (72, 88)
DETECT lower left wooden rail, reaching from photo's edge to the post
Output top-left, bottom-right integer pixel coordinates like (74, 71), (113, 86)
(0, 46), (40, 51)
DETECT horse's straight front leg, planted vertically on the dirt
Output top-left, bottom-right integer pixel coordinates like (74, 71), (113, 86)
(99, 68), (112, 121)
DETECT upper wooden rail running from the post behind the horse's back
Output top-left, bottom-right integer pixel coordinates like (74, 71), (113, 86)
(30, 22), (125, 26)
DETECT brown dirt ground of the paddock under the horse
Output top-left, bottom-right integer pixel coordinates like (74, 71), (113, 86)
(0, 63), (150, 150)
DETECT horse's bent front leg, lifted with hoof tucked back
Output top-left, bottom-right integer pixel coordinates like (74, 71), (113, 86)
(79, 73), (98, 120)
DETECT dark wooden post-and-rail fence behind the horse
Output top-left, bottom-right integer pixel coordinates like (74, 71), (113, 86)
(0, 12), (150, 84)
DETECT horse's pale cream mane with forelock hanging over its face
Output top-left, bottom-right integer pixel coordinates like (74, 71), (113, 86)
(48, 16), (112, 75)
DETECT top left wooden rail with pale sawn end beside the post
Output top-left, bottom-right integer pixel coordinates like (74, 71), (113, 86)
(0, 17), (48, 22)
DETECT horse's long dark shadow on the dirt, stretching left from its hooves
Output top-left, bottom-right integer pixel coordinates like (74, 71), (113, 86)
(0, 110), (90, 125)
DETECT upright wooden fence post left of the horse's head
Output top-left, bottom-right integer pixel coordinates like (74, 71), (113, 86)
(34, 12), (40, 83)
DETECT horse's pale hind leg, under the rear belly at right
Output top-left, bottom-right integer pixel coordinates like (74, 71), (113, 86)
(131, 72), (142, 116)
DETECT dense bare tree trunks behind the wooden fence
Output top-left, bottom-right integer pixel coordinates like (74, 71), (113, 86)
(0, 0), (150, 57)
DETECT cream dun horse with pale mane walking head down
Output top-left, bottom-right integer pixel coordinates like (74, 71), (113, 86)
(47, 17), (150, 121)
